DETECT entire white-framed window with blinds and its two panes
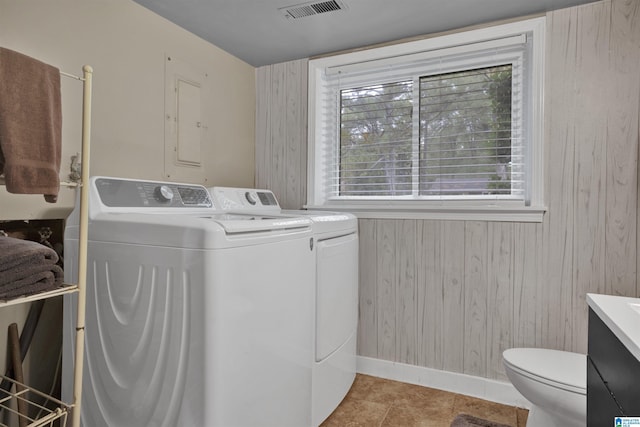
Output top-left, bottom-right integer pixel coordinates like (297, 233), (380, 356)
(308, 18), (544, 221)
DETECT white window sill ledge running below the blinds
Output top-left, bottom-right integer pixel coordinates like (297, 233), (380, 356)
(305, 202), (547, 222)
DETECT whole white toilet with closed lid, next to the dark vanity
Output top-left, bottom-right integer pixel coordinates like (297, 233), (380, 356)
(502, 348), (587, 427)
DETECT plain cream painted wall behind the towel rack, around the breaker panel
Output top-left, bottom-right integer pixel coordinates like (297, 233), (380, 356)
(0, 0), (255, 219)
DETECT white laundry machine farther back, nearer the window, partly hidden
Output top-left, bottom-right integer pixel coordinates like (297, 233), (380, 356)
(209, 187), (358, 426)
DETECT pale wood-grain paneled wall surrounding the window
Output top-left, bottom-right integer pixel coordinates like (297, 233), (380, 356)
(256, 0), (640, 379)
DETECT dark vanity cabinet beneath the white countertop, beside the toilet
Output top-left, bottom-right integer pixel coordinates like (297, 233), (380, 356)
(587, 308), (640, 427)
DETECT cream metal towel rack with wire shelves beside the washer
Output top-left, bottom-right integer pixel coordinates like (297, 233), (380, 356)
(0, 65), (93, 427)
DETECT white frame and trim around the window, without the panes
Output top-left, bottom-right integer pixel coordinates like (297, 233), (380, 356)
(306, 17), (546, 222)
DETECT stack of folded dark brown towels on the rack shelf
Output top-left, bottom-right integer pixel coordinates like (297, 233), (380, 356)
(0, 236), (64, 299)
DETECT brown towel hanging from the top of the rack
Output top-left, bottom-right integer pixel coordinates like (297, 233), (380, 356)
(0, 47), (62, 203)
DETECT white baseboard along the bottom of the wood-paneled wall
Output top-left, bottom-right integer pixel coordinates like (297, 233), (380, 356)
(356, 356), (531, 409)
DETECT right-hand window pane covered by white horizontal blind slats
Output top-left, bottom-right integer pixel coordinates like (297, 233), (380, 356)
(419, 64), (525, 199)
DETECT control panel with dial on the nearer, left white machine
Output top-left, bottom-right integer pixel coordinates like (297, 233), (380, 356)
(95, 178), (213, 208)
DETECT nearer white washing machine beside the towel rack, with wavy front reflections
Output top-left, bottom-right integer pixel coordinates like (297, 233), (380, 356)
(63, 177), (316, 427)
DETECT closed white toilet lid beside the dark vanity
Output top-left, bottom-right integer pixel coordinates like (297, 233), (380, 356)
(502, 348), (587, 390)
